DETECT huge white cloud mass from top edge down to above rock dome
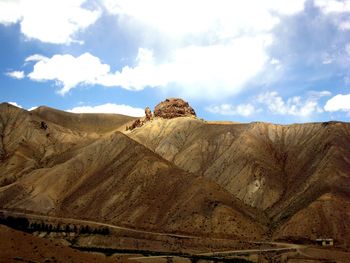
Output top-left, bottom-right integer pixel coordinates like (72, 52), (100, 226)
(99, 0), (305, 98)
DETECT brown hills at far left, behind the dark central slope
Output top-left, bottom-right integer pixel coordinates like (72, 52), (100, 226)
(0, 103), (134, 186)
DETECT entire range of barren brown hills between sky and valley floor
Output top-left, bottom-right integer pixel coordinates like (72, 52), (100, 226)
(0, 99), (350, 250)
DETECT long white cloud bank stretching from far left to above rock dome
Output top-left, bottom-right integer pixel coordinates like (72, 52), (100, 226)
(26, 39), (270, 98)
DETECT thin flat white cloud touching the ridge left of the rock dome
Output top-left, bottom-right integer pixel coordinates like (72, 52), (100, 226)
(67, 103), (145, 117)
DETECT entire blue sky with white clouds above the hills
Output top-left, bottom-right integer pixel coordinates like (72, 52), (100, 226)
(0, 0), (350, 124)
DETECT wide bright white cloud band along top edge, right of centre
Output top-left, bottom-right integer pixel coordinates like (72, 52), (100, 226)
(103, 0), (305, 37)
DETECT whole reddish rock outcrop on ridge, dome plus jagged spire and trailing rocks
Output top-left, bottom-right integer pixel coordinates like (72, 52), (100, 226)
(126, 98), (196, 131)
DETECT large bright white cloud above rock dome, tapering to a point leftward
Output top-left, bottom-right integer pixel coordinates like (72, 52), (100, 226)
(98, 36), (271, 99)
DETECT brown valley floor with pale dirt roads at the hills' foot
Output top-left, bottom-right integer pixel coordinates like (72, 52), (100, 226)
(0, 210), (350, 263)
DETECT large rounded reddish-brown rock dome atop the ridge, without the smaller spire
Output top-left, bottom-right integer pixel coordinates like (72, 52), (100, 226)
(154, 98), (196, 119)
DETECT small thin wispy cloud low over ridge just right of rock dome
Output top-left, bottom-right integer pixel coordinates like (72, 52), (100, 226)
(206, 103), (259, 117)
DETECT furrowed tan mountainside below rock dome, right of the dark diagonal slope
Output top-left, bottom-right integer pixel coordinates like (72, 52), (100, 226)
(127, 118), (350, 249)
